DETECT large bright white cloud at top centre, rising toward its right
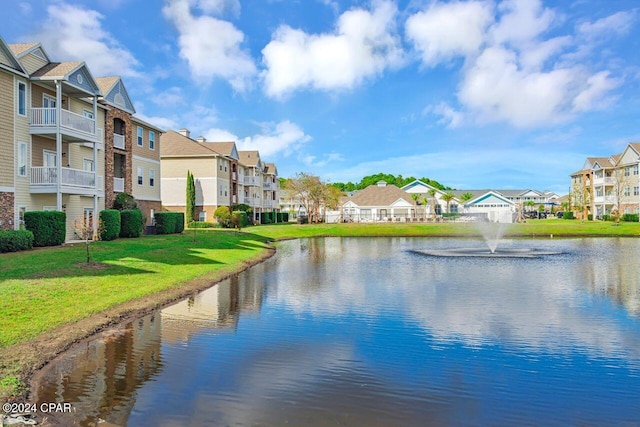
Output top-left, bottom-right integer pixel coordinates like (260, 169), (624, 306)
(262, 0), (403, 98)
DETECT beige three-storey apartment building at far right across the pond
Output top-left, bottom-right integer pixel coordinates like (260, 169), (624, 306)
(570, 142), (640, 219)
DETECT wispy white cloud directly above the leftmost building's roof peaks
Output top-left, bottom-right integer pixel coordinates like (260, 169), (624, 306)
(35, 3), (139, 77)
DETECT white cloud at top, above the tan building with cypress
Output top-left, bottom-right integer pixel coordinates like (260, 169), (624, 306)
(163, 0), (257, 91)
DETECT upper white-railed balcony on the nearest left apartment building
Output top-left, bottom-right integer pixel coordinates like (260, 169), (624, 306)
(29, 108), (97, 142)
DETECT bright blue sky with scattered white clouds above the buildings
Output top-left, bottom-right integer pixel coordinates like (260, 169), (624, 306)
(0, 0), (640, 194)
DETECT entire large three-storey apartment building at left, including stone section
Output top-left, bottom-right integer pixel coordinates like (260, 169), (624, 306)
(0, 37), (162, 240)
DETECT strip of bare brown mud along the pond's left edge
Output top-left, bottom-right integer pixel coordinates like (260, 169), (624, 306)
(0, 245), (276, 402)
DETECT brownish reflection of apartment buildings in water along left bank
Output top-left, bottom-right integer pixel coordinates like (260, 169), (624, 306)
(32, 276), (264, 427)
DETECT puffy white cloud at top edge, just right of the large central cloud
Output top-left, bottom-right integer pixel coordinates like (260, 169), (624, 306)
(406, 1), (493, 66)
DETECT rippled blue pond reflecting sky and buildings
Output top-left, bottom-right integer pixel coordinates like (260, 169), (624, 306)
(32, 238), (640, 426)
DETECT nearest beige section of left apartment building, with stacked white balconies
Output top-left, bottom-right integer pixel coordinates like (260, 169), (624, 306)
(0, 39), (105, 240)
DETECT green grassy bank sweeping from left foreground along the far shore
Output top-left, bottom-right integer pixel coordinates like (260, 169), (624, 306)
(0, 219), (640, 401)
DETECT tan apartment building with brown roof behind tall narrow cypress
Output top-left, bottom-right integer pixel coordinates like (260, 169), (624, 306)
(161, 129), (279, 222)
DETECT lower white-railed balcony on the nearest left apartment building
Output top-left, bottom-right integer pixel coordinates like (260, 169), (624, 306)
(30, 166), (104, 195)
